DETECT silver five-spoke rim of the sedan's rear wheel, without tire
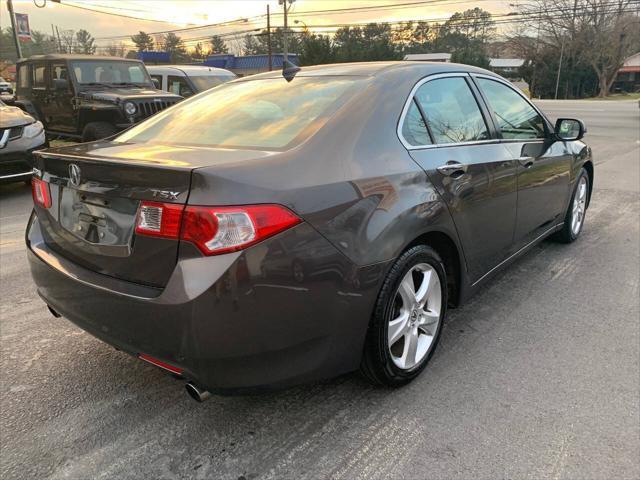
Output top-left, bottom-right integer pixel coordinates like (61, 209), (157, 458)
(387, 263), (442, 370)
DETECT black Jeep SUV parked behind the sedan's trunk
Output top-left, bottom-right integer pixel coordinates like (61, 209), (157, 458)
(15, 54), (181, 142)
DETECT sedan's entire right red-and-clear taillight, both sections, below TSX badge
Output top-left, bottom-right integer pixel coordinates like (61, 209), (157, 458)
(136, 202), (301, 255)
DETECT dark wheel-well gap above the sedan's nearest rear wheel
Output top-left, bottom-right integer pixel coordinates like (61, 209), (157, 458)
(400, 230), (464, 307)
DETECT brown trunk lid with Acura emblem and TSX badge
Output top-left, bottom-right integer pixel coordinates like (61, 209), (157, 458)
(31, 141), (197, 287)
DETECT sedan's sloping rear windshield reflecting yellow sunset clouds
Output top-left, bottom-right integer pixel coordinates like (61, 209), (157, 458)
(115, 77), (364, 149)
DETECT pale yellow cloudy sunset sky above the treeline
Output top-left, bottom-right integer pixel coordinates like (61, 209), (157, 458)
(0, 0), (509, 50)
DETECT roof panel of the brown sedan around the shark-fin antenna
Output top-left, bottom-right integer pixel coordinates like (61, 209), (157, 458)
(242, 60), (498, 80)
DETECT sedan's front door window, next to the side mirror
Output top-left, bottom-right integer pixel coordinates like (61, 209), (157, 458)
(476, 78), (547, 140)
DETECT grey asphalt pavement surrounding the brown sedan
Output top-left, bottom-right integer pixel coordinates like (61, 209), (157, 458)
(0, 101), (640, 480)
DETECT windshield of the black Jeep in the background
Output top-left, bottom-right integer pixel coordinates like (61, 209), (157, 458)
(71, 60), (154, 88)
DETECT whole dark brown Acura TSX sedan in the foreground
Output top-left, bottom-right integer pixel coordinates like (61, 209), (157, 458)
(27, 62), (594, 400)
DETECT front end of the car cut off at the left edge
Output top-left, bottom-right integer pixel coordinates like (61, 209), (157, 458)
(0, 100), (48, 183)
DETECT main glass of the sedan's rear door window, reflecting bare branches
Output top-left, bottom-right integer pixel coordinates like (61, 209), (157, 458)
(416, 77), (489, 144)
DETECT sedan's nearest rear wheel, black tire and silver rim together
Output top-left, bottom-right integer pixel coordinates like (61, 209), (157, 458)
(360, 245), (447, 387)
